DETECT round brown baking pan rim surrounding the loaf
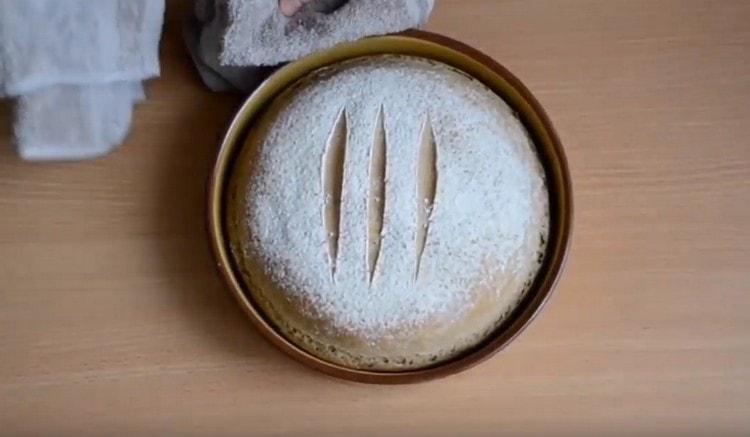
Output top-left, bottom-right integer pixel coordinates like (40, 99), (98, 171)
(208, 31), (573, 384)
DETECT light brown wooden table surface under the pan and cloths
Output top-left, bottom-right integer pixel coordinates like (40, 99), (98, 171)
(0, 0), (750, 435)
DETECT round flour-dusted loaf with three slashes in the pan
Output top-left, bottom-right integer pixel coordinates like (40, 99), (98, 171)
(226, 55), (549, 371)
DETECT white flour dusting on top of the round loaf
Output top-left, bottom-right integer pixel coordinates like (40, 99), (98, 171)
(238, 56), (548, 339)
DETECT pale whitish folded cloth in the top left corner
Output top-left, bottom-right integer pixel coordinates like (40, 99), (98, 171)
(0, 0), (164, 160)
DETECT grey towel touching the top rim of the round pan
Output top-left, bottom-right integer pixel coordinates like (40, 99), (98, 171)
(185, 0), (434, 92)
